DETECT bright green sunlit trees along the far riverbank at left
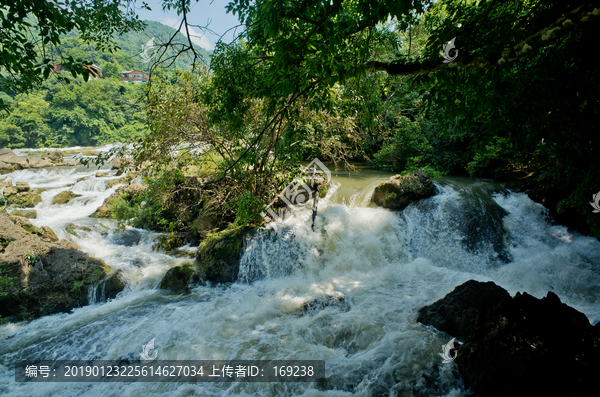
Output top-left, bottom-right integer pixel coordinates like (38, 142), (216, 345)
(0, 79), (145, 148)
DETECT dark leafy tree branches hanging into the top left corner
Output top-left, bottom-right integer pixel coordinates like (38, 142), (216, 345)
(0, 0), (148, 110)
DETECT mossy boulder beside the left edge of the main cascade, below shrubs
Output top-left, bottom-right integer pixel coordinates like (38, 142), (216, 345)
(197, 226), (249, 282)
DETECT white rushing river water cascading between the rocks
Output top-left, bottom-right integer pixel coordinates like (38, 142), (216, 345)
(0, 159), (600, 397)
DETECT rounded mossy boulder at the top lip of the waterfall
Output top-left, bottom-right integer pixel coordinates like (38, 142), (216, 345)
(371, 172), (435, 210)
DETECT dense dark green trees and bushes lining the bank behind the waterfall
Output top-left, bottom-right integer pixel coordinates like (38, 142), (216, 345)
(1, 0), (600, 237)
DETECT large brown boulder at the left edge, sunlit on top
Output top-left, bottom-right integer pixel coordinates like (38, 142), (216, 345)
(0, 213), (118, 319)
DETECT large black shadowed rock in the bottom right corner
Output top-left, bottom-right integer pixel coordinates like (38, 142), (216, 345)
(419, 281), (600, 397)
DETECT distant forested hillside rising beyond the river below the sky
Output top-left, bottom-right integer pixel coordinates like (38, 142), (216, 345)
(0, 21), (209, 148)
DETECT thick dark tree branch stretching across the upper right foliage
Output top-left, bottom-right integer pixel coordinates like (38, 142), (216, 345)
(366, 3), (600, 76)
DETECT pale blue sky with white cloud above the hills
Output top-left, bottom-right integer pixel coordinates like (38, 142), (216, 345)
(135, 0), (239, 50)
